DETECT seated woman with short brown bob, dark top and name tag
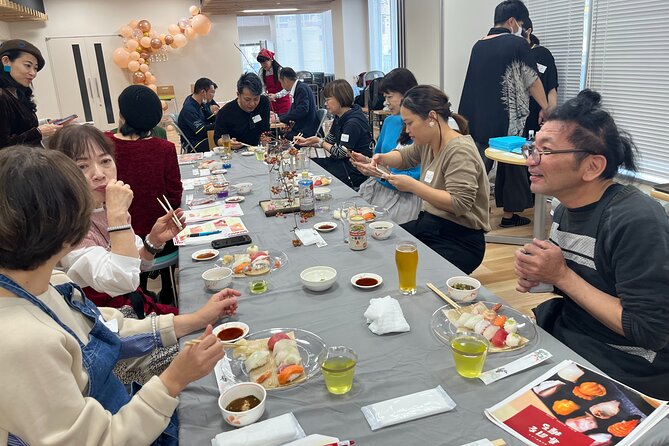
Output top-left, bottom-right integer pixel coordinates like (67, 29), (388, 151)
(295, 79), (372, 190)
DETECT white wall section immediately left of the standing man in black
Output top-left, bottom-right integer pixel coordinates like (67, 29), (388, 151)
(443, 0), (500, 111)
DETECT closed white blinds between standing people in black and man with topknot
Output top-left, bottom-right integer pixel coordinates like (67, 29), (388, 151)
(525, 0), (585, 104)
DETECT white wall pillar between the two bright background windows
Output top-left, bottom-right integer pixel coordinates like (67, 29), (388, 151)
(332, 0), (369, 84)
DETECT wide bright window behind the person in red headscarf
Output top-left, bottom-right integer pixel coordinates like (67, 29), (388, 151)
(273, 11), (334, 73)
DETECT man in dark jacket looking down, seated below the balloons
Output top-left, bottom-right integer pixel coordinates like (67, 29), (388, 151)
(178, 77), (216, 152)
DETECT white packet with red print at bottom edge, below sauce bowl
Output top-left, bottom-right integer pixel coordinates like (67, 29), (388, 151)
(211, 412), (305, 446)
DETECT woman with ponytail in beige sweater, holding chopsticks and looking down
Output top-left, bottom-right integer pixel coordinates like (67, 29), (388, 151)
(352, 85), (490, 274)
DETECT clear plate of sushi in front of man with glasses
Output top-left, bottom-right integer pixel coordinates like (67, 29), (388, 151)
(430, 302), (539, 353)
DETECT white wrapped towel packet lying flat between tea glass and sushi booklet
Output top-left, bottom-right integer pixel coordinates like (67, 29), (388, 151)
(361, 386), (455, 431)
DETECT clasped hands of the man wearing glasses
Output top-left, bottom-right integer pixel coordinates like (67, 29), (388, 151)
(515, 239), (569, 293)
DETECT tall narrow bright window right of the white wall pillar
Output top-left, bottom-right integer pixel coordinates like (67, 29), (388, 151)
(368, 0), (398, 73)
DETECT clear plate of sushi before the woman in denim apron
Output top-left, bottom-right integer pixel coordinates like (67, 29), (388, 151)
(224, 328), (325, 390)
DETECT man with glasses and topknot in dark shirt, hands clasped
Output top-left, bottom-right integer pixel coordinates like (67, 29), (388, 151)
(515, 90), (669, 399)
